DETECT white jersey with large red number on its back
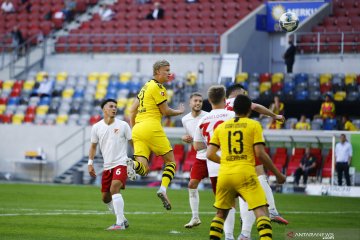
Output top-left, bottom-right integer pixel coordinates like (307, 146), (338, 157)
(194, 109), (235, 177)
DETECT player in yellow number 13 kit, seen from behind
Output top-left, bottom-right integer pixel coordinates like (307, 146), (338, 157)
(206, 95), (285, 240)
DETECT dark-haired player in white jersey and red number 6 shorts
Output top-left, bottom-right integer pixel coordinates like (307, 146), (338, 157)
(88, 99), (136, 230)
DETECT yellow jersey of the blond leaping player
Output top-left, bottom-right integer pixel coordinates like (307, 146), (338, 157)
(135, 79), (167, 124)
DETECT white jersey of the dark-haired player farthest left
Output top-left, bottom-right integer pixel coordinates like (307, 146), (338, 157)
(91, 118), (132, 170)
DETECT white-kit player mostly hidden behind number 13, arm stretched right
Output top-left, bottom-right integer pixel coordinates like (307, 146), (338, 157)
(226, 84), (289, 240)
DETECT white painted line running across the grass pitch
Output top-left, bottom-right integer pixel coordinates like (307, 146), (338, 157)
(0, 209), (360, 217)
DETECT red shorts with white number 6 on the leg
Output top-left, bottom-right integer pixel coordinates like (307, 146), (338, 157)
(101, 165), (127, 192)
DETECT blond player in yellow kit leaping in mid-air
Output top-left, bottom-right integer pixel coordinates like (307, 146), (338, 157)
(130, 60), (185, 210)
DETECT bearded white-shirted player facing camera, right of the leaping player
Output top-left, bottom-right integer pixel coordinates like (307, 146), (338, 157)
(181, 92), (209, 228)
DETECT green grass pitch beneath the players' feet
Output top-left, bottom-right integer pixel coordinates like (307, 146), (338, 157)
(0, 183), (360, 240)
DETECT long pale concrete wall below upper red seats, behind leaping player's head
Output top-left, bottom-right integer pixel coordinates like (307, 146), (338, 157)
(45, 54), (219, 82)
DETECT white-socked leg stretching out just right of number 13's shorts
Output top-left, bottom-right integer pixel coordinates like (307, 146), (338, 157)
(255, 165), (289, 224)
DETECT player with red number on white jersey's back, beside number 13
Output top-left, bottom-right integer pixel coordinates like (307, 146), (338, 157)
(194, 85), (235, 240)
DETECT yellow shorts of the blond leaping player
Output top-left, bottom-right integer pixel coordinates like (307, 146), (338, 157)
(132, 122), (172, 160)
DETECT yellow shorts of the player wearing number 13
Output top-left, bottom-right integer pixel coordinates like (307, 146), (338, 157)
(214, 166), (267, 210)
